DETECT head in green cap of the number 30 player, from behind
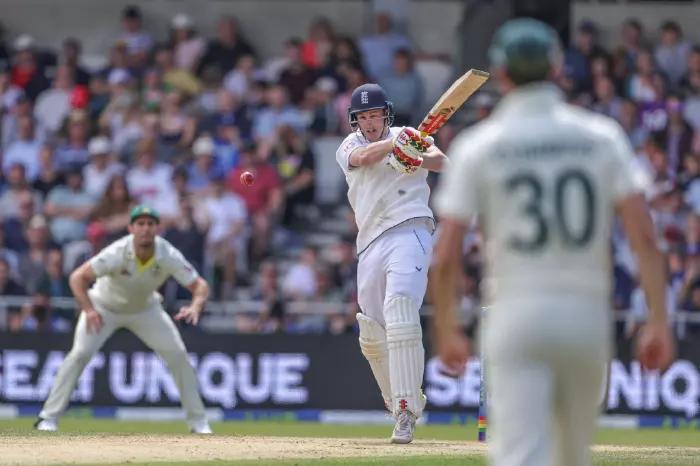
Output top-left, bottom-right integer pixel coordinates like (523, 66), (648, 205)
(489, 18), (562, 85)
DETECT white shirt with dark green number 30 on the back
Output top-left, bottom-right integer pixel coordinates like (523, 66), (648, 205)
(437, 84), (648, 300)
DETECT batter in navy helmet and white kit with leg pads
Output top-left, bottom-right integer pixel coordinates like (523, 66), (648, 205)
(336, 84), (446, 443)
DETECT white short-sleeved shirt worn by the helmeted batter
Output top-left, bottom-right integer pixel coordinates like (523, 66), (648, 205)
(335, 127), (433, 254)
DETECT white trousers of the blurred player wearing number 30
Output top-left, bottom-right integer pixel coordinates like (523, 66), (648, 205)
(483, 295), (612, 466)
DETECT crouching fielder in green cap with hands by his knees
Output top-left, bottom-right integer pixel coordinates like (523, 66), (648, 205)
(35, 206), (211, 434)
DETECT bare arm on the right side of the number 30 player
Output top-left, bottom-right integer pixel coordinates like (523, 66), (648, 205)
(617, 194), (674, 369)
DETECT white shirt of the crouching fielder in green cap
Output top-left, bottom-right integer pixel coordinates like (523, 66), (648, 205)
(88, 235), (199, 313)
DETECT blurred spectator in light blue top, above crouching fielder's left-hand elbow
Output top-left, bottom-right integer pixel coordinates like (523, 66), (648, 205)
(44, 166), (95, 245)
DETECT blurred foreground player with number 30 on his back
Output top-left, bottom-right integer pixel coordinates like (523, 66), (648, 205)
(431, 19), (673, 466)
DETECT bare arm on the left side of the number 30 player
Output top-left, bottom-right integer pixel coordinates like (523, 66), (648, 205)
(430, 217), (469, 375)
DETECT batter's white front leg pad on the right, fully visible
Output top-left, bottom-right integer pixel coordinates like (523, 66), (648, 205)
(384, 296), (425, 417)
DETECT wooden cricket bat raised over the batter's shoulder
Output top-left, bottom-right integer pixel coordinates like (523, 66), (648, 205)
(418, 68), (489, 137)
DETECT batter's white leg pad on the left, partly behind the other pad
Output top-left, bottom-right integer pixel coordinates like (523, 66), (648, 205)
(355, 312), (391, 410)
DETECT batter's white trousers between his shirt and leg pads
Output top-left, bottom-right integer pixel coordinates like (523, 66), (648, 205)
(357, 218), (433, 327)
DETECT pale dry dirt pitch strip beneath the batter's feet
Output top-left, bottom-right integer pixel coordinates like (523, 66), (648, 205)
(0, 434), (700, 465)
